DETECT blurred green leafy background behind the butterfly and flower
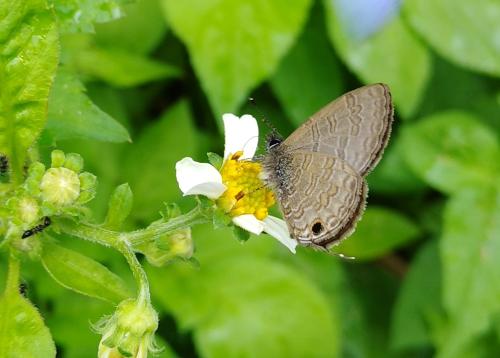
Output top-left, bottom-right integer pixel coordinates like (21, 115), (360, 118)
(0, 0), (500, 358)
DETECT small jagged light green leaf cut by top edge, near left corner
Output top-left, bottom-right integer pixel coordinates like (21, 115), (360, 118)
(48, 0), (128, 32)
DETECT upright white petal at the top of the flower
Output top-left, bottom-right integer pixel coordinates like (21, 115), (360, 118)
(222, 113), (259, 160)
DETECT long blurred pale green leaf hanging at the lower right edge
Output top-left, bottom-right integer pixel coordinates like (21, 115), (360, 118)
(439, 187), (500, 357)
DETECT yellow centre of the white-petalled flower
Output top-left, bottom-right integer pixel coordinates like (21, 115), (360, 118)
(217, 151), (275, 220)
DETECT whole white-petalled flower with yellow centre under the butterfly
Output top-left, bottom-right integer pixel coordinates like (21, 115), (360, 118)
(175, 114), (297, 253)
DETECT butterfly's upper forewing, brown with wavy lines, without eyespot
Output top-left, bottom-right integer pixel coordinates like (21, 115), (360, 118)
(284, 83), (393, 176)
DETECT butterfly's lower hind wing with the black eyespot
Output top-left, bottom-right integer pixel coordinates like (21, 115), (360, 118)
(264, 151), (367, 248)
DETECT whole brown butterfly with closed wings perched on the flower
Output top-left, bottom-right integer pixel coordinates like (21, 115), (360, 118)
(263, 83), (393, 249)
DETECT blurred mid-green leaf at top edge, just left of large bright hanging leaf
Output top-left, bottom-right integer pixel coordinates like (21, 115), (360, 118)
(96, 0), (167, 55)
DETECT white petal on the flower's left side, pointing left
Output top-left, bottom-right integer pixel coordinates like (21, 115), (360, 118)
(175, 157), (226, 199)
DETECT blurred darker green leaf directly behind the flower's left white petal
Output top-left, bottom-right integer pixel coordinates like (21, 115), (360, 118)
(123, 101), (198, 219)
